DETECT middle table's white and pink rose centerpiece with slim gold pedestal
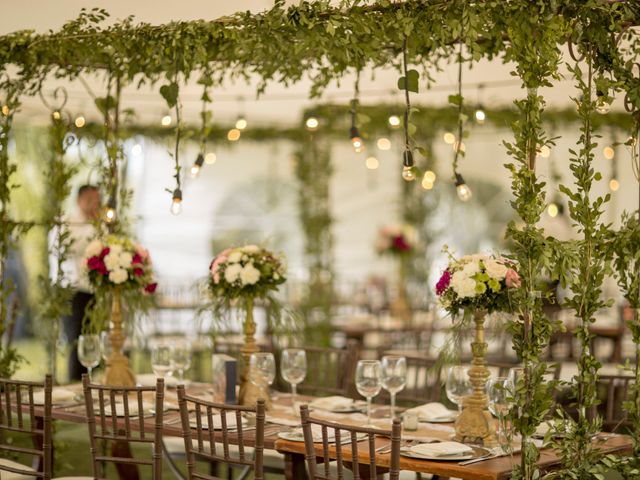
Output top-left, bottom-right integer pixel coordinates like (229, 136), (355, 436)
(209, 245), (286, 405)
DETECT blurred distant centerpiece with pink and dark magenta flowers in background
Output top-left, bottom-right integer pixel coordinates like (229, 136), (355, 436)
(375, 225), (416, 322)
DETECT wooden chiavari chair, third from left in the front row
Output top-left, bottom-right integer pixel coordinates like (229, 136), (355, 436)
(178, 385), (265, 480)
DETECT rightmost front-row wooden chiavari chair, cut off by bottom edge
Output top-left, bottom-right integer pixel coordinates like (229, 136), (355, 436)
(300, 405), (402, 480)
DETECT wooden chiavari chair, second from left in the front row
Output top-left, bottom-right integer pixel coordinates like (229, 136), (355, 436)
(82, 375), (164, 480)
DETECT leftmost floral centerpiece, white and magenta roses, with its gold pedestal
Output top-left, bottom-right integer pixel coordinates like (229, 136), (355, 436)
(84, 235), (158, 387)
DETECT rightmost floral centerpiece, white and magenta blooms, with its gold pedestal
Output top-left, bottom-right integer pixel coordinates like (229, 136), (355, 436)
(436, 254), (520, 447)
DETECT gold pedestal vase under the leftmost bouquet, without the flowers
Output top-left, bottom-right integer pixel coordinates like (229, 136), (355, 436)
(104, 289), (136, 387)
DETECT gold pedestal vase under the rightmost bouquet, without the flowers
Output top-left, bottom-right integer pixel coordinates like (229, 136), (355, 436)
(455, 310), (498, 447)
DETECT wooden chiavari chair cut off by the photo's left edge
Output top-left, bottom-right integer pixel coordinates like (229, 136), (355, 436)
(0, 375), (53, 480)
